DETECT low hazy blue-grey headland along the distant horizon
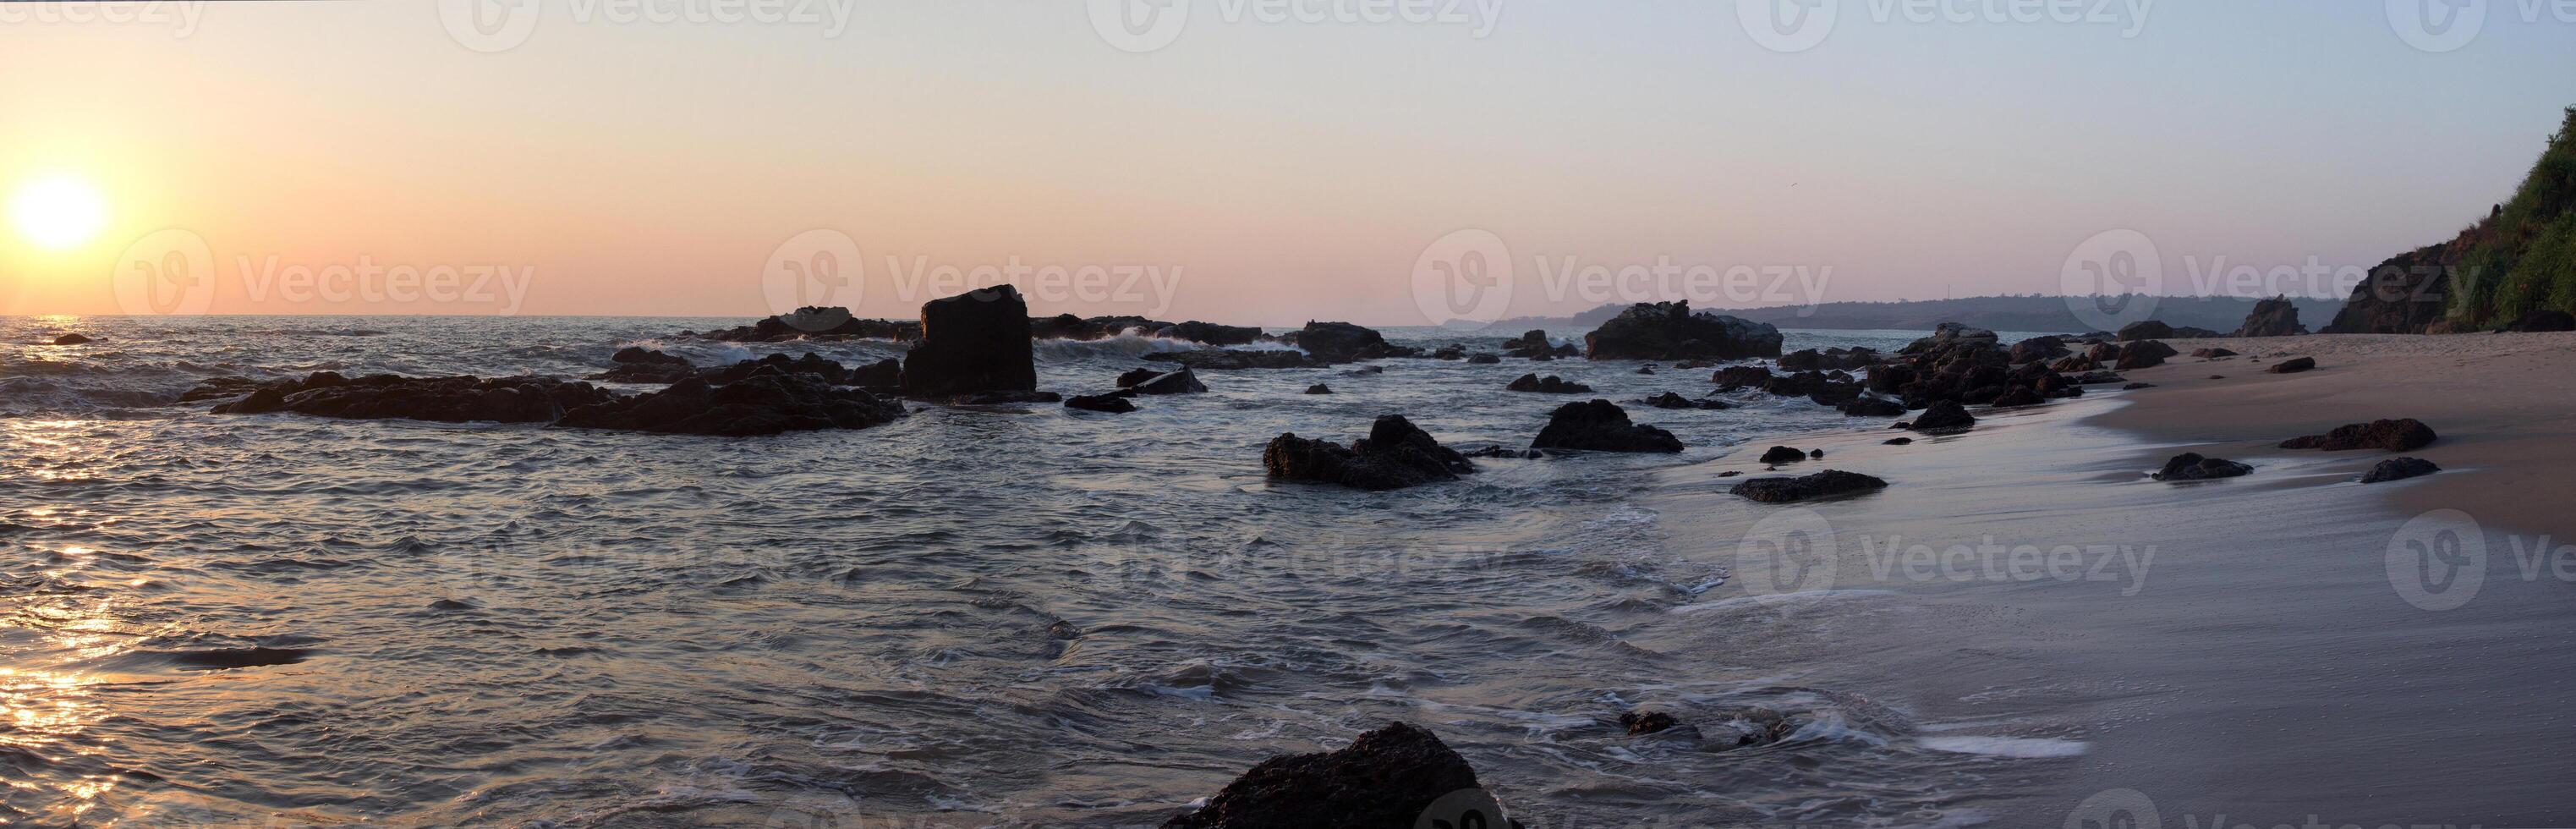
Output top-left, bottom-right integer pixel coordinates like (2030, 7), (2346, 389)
(1489, 294), (2342, 338)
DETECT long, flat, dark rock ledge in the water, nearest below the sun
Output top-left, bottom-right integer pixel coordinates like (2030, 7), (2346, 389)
(214, 371), (616, 422)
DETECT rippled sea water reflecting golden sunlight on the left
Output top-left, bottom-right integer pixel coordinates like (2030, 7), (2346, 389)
(0, 316), (2046, 826)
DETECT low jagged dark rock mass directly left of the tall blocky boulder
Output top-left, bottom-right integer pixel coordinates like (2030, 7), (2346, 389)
(556, 365), (907, 437)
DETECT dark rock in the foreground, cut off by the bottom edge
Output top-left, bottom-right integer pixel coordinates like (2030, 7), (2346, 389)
(1162, 723), (1507, 829)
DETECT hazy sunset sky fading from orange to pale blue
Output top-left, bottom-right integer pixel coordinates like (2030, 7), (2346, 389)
(0, 0), (2576, 324)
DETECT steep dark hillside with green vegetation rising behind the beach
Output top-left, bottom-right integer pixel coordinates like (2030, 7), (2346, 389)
(2327, 106), (2576, 335)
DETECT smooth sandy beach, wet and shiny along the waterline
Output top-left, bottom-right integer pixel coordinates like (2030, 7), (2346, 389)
(1657, 335), (2576, 826)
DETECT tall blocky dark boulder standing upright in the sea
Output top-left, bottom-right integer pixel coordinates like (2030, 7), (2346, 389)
(904, 286), (1039, 397)
